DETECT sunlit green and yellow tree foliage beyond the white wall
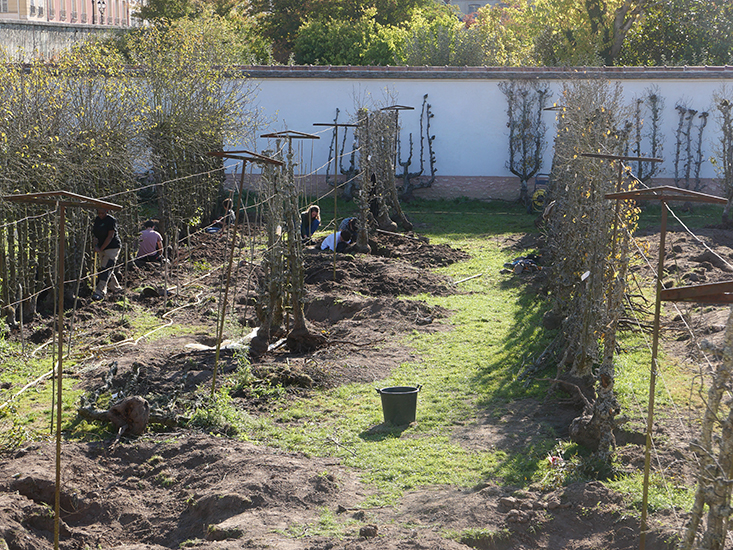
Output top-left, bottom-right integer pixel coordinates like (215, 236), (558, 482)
(129, 0), (733, 66)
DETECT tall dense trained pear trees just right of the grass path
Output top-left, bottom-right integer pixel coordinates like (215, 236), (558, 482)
(547, 80), (636, 459)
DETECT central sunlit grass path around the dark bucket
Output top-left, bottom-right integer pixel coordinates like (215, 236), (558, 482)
(239, 203), (554, 504)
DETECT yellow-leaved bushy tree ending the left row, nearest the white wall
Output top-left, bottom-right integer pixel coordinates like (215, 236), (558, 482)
(121, 16), (255, 237)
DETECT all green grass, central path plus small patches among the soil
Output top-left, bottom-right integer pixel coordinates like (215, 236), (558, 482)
(0, 200), (696, 506)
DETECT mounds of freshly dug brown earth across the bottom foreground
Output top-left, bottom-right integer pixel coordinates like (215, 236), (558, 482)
(0, 436), (672, 550)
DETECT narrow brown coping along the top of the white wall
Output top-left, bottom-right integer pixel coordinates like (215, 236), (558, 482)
(239, 65), (733, 80)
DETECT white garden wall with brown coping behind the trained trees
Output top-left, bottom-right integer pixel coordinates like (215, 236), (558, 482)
(233, 67), (733, 199)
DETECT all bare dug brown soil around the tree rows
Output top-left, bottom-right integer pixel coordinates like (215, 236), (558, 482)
(0, 225), (733, 550)
